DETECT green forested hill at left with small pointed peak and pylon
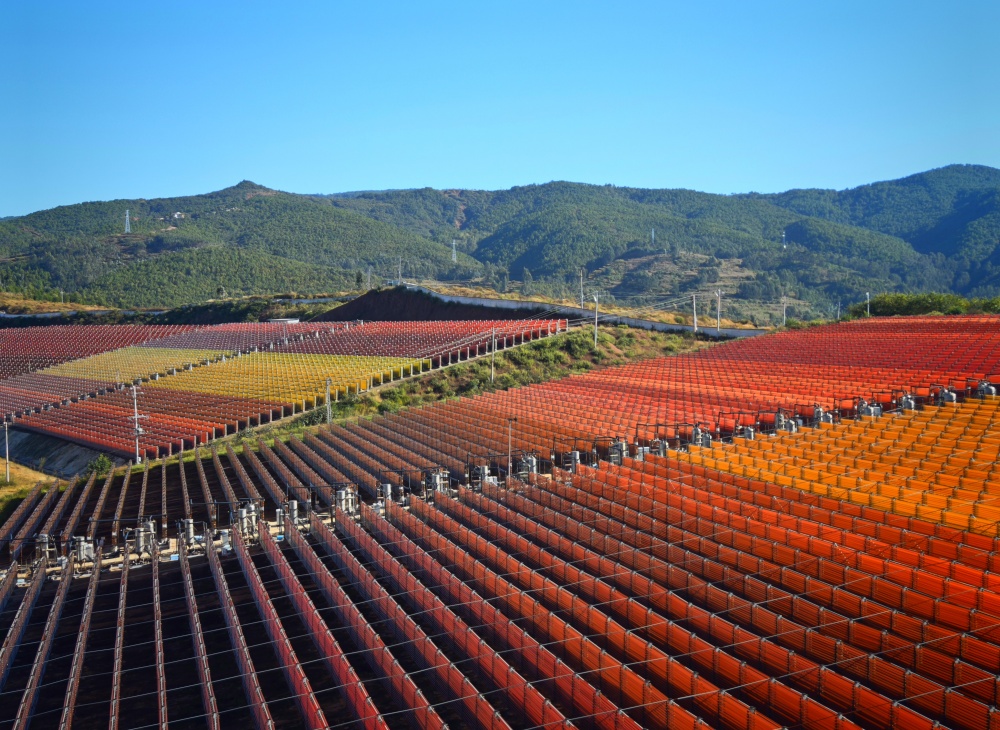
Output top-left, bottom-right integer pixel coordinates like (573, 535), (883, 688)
(0, 182), (481, 306)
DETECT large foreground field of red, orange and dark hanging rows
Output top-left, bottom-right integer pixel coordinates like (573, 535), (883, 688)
(0, 317), (1000, 730)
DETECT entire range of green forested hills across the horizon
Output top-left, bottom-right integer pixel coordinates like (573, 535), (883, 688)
(0, 165), (1000, 318)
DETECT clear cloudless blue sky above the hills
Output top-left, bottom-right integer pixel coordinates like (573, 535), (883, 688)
(0, 0), (1000, 216)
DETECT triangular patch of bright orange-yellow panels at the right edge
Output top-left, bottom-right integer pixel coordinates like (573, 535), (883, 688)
(678, 398), (1000, 535)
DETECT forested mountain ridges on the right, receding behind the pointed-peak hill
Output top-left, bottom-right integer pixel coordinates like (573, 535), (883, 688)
(331, 165), (1000, 311)
